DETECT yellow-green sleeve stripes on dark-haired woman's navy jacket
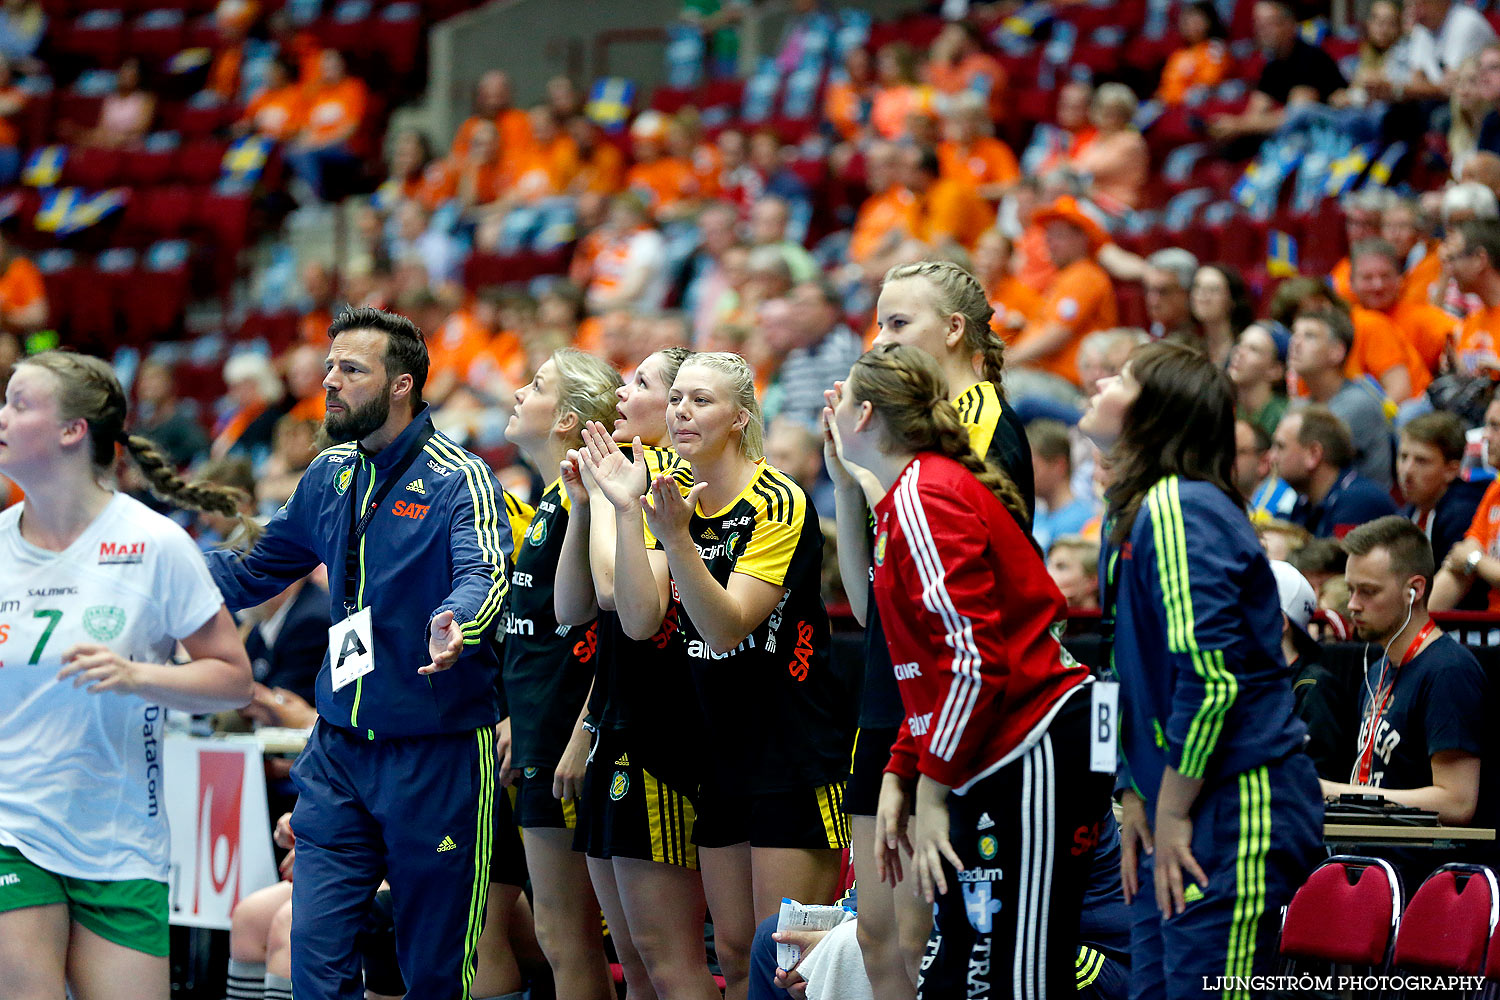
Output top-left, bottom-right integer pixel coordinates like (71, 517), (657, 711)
(1146, 475), (1239, 778)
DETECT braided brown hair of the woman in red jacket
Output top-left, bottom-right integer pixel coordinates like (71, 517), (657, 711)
(845, 343), (1029, 525)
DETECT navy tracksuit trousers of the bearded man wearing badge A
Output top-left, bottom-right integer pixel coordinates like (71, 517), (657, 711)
(291, 720), (495, 1000)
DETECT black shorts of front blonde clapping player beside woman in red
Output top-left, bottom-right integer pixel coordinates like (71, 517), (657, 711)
(693, 781), (849, 850)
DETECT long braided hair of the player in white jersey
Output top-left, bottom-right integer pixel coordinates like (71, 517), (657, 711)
(17, 351), (260, 537)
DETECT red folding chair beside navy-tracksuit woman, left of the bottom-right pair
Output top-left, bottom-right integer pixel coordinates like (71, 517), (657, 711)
(1281, 855), (1401, 969)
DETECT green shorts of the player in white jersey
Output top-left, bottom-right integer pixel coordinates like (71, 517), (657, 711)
(0, 844), (168, 957)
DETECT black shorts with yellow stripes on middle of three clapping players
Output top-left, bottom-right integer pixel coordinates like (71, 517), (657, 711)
(573, 730), (698, 871)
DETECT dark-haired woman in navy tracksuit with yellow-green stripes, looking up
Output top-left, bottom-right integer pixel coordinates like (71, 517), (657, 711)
(1079, 340), (1323, 997)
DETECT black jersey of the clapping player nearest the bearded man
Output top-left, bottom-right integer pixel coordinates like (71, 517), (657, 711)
(501, 478), (599, 768)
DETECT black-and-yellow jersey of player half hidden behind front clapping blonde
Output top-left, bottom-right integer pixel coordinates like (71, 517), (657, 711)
(590, 445), (705, 793)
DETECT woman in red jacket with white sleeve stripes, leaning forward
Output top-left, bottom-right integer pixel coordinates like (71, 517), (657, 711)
(825, 345), (1110, 999)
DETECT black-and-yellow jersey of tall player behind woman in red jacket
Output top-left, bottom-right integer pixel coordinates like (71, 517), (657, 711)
(860, 382), (1037, 729)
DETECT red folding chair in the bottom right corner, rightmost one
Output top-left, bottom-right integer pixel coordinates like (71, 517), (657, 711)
(1394, 865), (1500, 976)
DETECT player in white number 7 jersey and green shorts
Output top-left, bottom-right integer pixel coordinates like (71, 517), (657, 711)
(0, 351), (251, 1000)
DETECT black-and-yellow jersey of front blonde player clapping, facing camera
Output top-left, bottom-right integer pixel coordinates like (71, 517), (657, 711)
(672, 462), (858, 793)
